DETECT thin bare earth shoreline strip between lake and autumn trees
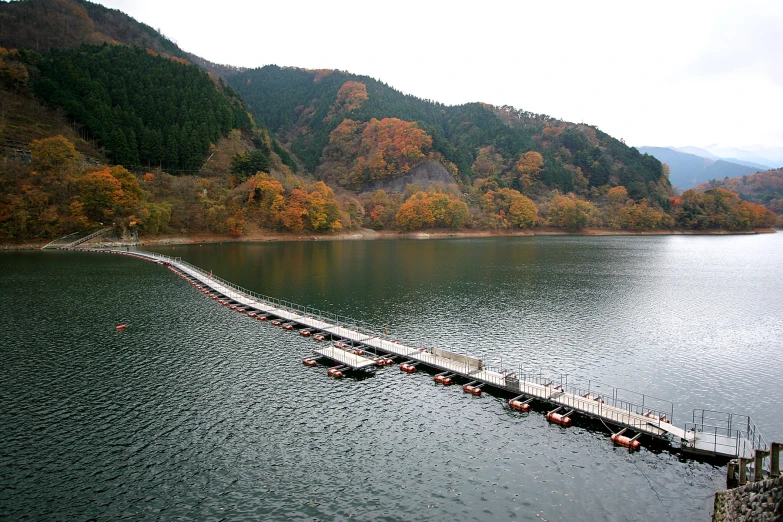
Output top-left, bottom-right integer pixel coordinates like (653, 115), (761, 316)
(0, 227), (777, 251)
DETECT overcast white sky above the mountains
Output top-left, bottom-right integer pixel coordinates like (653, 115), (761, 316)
(98, 0), (783, 153)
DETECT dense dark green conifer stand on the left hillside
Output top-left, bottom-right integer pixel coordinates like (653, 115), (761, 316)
(26, 45), (252, 171)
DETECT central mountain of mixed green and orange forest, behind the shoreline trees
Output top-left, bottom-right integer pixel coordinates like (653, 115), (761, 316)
(229, 66), (668, 206)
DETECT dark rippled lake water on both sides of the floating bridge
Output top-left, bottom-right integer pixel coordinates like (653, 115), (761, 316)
(0, 234), (783, 521)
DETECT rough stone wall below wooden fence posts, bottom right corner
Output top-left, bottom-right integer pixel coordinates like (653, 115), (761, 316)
(712, 477), (783, 522)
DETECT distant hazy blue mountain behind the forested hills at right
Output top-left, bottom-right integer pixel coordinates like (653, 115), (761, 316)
(639, 147), (759, 189)
